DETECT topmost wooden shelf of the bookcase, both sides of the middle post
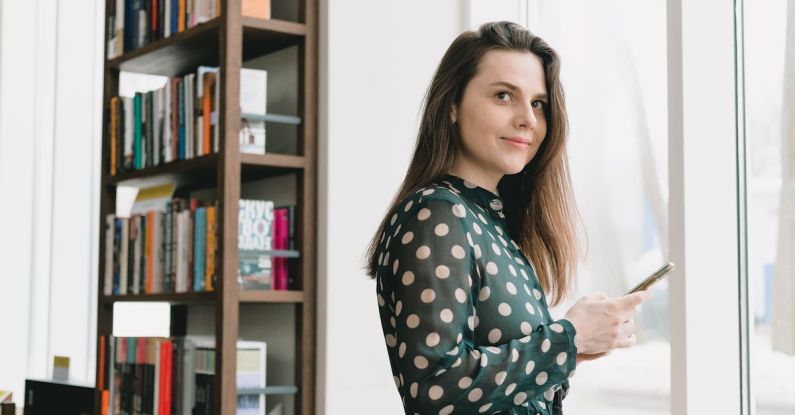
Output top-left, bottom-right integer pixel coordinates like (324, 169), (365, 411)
(108, 17), (306, 76)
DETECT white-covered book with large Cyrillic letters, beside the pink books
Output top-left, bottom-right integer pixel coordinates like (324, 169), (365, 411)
(237, 199), (273, 289)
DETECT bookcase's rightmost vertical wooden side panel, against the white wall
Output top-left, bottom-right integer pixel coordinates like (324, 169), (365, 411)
(296, 0), (317, 414)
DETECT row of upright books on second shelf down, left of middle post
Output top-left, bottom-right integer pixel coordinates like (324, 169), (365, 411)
(107, 66), (220, 175)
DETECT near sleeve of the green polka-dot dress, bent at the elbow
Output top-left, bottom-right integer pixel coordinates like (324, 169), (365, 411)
(378, 200), (577, 414)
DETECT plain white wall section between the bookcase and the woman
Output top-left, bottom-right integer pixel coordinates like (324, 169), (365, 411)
(317, 0), (467, 414)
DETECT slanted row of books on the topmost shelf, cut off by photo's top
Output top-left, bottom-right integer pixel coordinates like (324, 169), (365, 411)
(105, 0), (221, 59)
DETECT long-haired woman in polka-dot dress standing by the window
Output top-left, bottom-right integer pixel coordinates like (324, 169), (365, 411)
(368, 22), (649, 414)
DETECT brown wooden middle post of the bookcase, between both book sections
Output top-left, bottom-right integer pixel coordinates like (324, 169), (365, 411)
(214, 0), (243, 415)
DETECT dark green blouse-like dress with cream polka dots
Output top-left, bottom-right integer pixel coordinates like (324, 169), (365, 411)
(376, 174), (577, 414)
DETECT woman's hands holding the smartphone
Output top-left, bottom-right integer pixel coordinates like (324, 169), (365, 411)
(564, 290), (651, 354)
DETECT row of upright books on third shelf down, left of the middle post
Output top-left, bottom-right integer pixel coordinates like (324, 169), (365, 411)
(104, 198), (218, 295)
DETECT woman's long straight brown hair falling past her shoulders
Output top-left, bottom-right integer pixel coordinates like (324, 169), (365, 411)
(367, 22), (579, 305)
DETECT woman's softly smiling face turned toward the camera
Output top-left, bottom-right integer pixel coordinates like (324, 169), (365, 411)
(451, 50), (549, 183)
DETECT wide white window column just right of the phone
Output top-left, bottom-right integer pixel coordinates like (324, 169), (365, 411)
(667, 0), (741, 415)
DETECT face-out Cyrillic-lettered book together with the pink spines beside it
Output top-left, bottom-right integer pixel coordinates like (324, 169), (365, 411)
(237, 200), (298, 290)
